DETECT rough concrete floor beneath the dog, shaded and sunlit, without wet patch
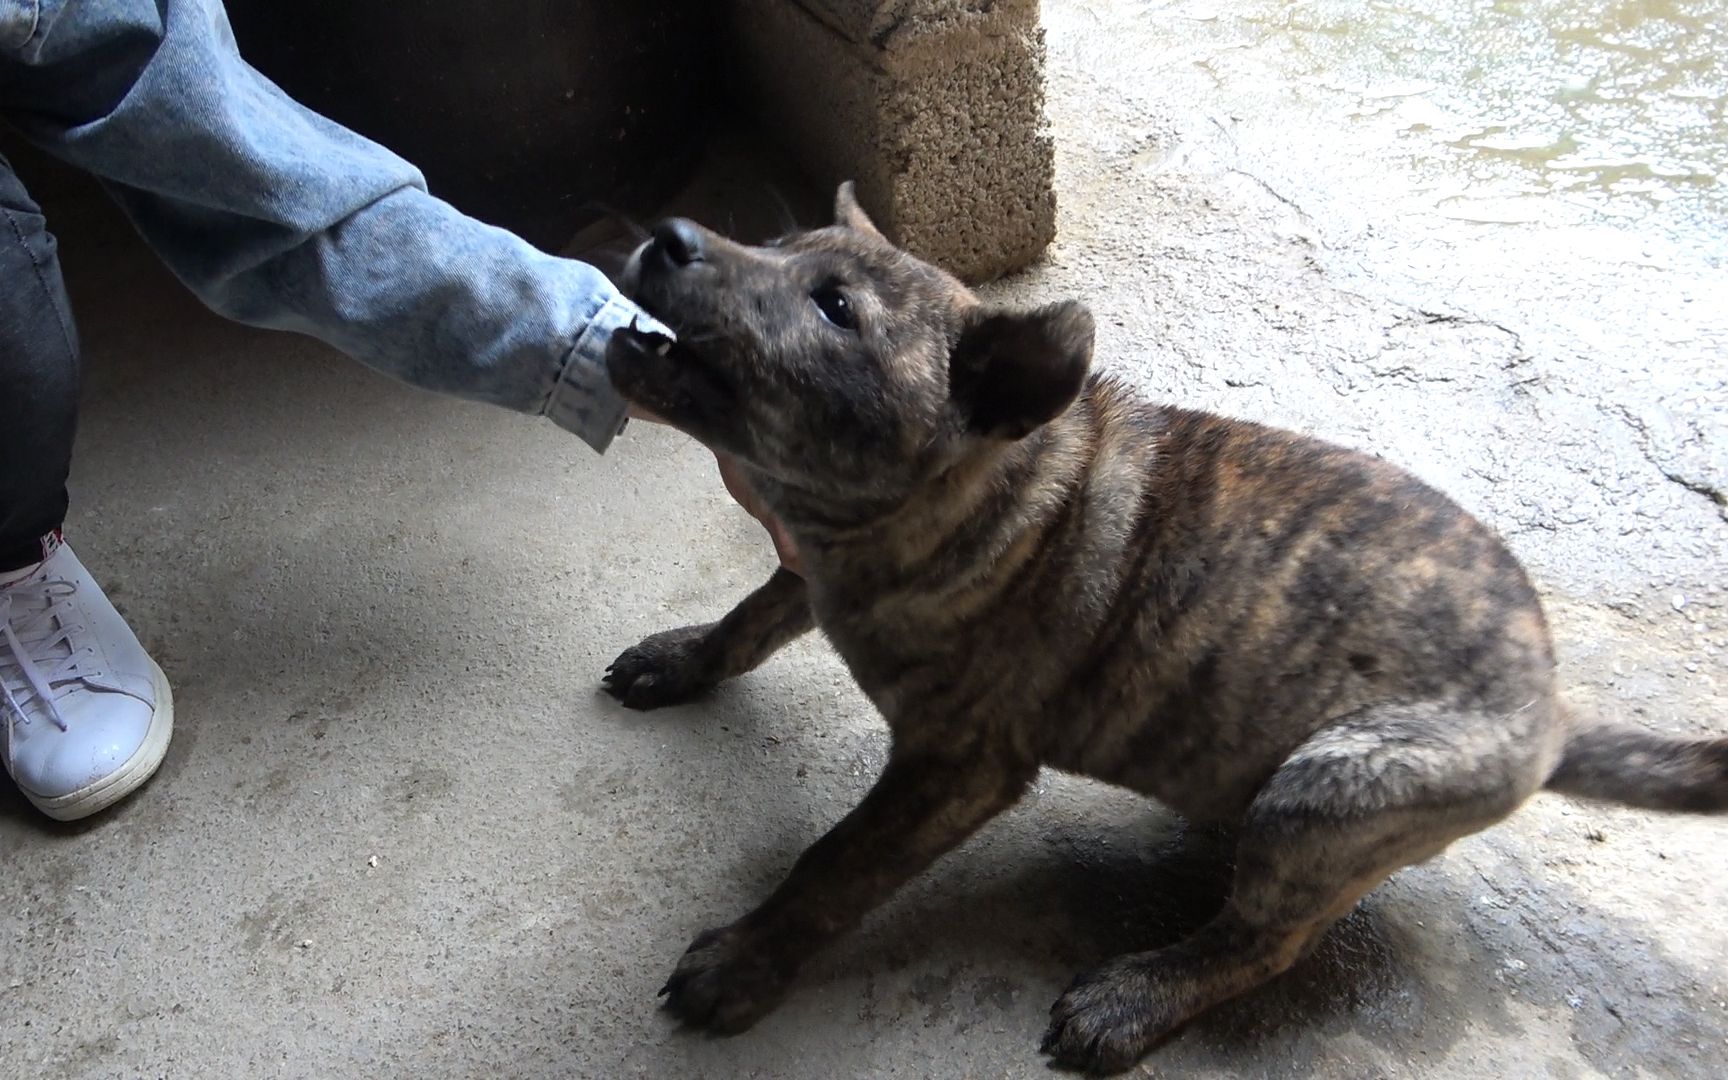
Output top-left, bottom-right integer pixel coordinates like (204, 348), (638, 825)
(0, 2), (1728, 1078)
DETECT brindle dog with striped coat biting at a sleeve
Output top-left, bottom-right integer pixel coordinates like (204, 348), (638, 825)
(607, 187), (1728, 1071)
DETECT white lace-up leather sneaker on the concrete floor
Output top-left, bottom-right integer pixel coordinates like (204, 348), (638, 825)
(0, 537), (175, 821)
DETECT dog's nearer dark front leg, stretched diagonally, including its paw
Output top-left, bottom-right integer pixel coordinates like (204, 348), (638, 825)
(662, 745), (1037, 1032)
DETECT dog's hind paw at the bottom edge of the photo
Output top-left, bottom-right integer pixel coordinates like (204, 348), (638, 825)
(1039, 957), (1182, 1075)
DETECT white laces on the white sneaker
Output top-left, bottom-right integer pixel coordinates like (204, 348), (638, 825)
(0, 577), (92, 731)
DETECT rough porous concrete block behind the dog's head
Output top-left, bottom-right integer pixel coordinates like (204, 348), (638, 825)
(729, 0), (1056, 282)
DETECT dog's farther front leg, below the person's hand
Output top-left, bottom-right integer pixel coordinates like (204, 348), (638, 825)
(605, 567), (816, 708)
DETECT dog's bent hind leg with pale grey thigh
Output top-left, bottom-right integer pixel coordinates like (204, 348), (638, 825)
(1044, 702), (1559, 1071)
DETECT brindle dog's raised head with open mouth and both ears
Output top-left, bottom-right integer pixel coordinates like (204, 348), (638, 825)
(607, 185), (1092, 505)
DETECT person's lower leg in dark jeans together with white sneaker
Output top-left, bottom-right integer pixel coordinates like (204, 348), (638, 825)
(0, 157), (173, 821)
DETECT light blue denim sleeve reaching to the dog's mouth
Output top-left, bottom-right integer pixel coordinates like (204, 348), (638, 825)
(0, 0), (664, 451)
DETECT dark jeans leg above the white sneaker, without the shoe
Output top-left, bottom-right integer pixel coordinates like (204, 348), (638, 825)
(0, 157), (78, 575)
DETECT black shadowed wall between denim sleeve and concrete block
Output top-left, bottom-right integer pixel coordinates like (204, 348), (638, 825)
(228, 0), (721, 251)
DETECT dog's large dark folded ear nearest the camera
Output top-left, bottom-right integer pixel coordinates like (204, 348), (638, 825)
(949, 301), (1092, 439)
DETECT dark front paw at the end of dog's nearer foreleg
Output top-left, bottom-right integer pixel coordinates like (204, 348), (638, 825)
(660, 926), (788, 1035)
